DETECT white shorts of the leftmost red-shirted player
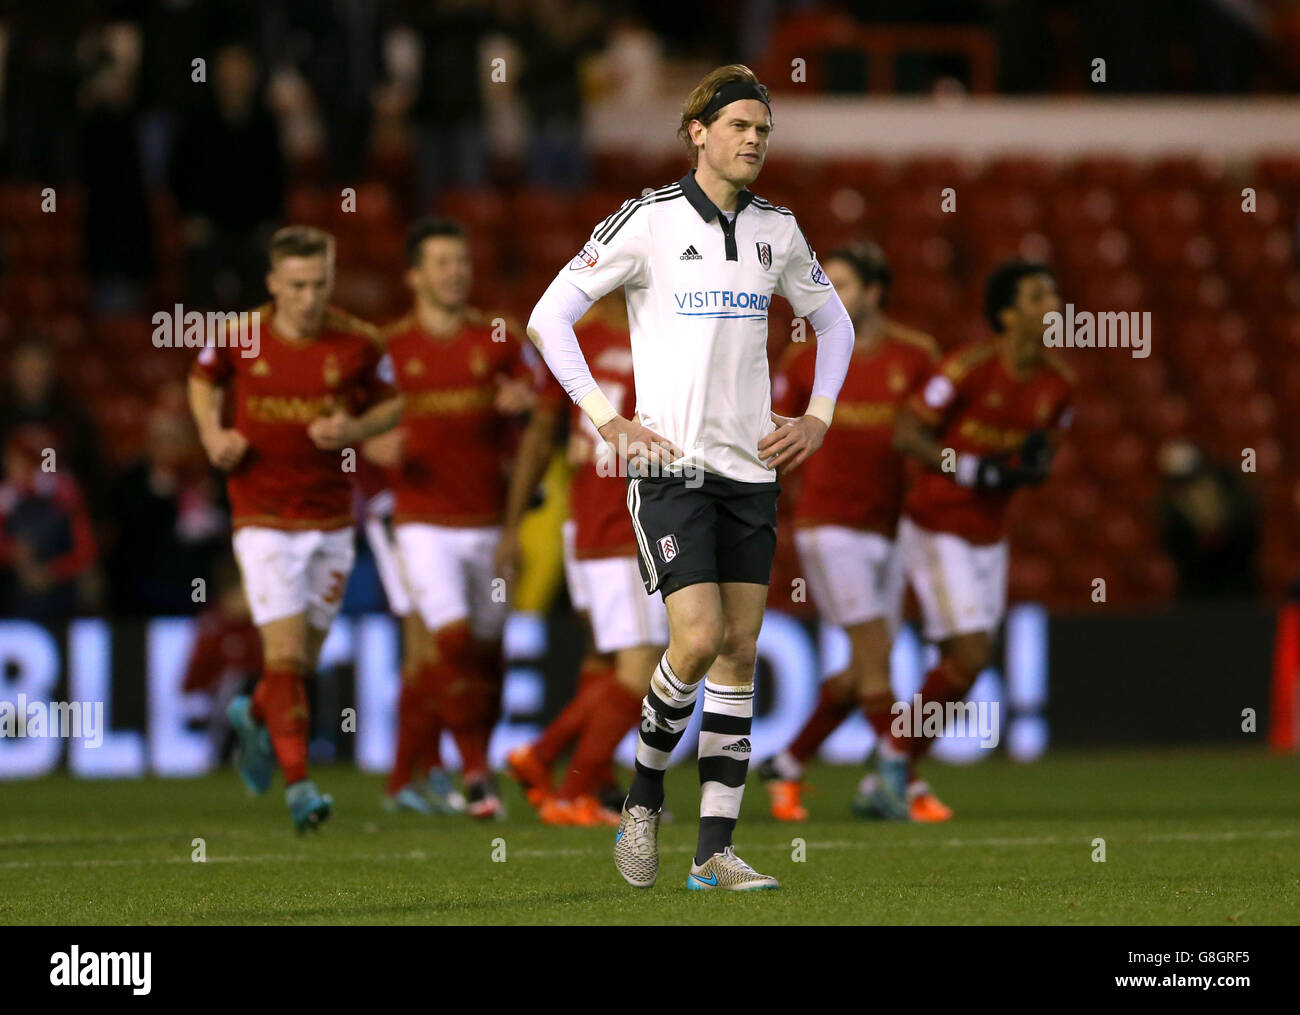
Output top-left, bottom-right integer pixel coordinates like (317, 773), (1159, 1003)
(233, 525), (356, 630)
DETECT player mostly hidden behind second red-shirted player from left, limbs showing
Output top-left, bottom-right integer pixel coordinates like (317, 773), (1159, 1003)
(356, 452), (465, 815)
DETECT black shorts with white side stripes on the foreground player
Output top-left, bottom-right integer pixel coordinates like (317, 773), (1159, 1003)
(628, 469), (781, 599)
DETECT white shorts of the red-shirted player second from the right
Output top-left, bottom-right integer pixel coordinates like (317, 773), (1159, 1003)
(794, 525), (904, 633)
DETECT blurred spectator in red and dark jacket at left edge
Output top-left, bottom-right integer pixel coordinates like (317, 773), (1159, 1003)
(0, 426), (95, 621)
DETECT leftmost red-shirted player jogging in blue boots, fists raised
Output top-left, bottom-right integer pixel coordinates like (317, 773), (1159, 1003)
(190, 226), (402, 832)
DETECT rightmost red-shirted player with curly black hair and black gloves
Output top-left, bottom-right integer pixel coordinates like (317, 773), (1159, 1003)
(870, 261), (1073, 819)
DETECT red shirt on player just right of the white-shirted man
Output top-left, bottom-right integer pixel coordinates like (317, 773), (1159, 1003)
(775, 321), (939, 538)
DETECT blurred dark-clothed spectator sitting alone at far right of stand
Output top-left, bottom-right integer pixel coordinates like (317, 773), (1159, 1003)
(1158, 441), (1260, 599)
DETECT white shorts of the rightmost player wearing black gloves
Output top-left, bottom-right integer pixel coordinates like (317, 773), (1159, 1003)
(898, 519), (1009, 641)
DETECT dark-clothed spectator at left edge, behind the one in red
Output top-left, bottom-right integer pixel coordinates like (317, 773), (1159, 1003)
(0, 334), (104, 515)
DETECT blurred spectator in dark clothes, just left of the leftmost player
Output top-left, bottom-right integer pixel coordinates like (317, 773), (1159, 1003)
(108, 394), (229, 617)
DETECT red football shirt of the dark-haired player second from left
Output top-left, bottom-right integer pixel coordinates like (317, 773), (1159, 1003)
(384, 311), (540, 526)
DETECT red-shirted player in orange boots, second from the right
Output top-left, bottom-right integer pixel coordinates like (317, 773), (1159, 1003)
(758, 243), (952, 821)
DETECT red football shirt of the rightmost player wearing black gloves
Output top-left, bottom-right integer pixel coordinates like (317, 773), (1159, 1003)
(904, 340), (1071, 543)
